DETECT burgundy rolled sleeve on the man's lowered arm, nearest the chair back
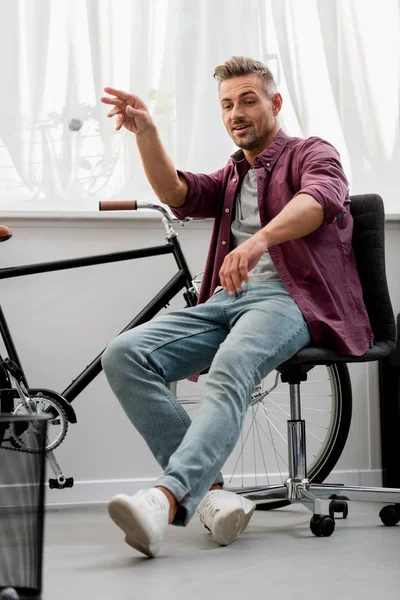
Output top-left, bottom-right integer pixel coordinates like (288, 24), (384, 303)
(294, 137), (350, 225)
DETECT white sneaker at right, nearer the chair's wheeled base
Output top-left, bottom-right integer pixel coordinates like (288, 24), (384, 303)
(197, 490), (256, 546)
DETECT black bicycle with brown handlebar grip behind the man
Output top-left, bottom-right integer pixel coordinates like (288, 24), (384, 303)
(0, 201), (352, 508)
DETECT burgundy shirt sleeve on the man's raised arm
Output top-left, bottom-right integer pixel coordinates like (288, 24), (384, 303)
(170, 169), (224, 219)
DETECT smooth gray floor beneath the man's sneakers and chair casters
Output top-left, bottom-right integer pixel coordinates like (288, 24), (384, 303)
(43, 503), (400, 600)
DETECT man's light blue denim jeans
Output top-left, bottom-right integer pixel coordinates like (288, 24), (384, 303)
(102, 282), (311, 526)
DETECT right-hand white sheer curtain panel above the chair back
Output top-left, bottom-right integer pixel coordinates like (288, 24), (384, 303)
(272, 0), (400, 215)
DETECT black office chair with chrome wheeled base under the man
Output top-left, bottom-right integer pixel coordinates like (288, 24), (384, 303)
(235, 194), (400, 537)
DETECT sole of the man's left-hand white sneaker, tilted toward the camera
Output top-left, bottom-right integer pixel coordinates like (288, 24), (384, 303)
(108, 496), (161, 558)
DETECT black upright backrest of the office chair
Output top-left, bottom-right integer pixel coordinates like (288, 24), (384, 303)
(350, 194), (396, 348)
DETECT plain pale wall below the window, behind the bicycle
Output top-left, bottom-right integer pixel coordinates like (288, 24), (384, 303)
(0, 215), (400, 503)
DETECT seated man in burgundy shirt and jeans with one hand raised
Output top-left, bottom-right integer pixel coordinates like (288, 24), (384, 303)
(102, 57), (372, 556)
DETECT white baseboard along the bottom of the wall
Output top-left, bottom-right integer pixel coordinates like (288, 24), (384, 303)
(46, 470), (382, 506)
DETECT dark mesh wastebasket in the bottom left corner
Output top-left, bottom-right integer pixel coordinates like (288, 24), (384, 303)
(0, 414), (51, 598)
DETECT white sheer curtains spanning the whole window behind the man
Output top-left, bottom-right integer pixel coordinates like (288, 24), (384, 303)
(0, 0), (400, 214)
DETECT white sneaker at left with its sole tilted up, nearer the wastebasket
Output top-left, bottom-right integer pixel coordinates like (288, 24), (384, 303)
(108, 487), (169, 558)
